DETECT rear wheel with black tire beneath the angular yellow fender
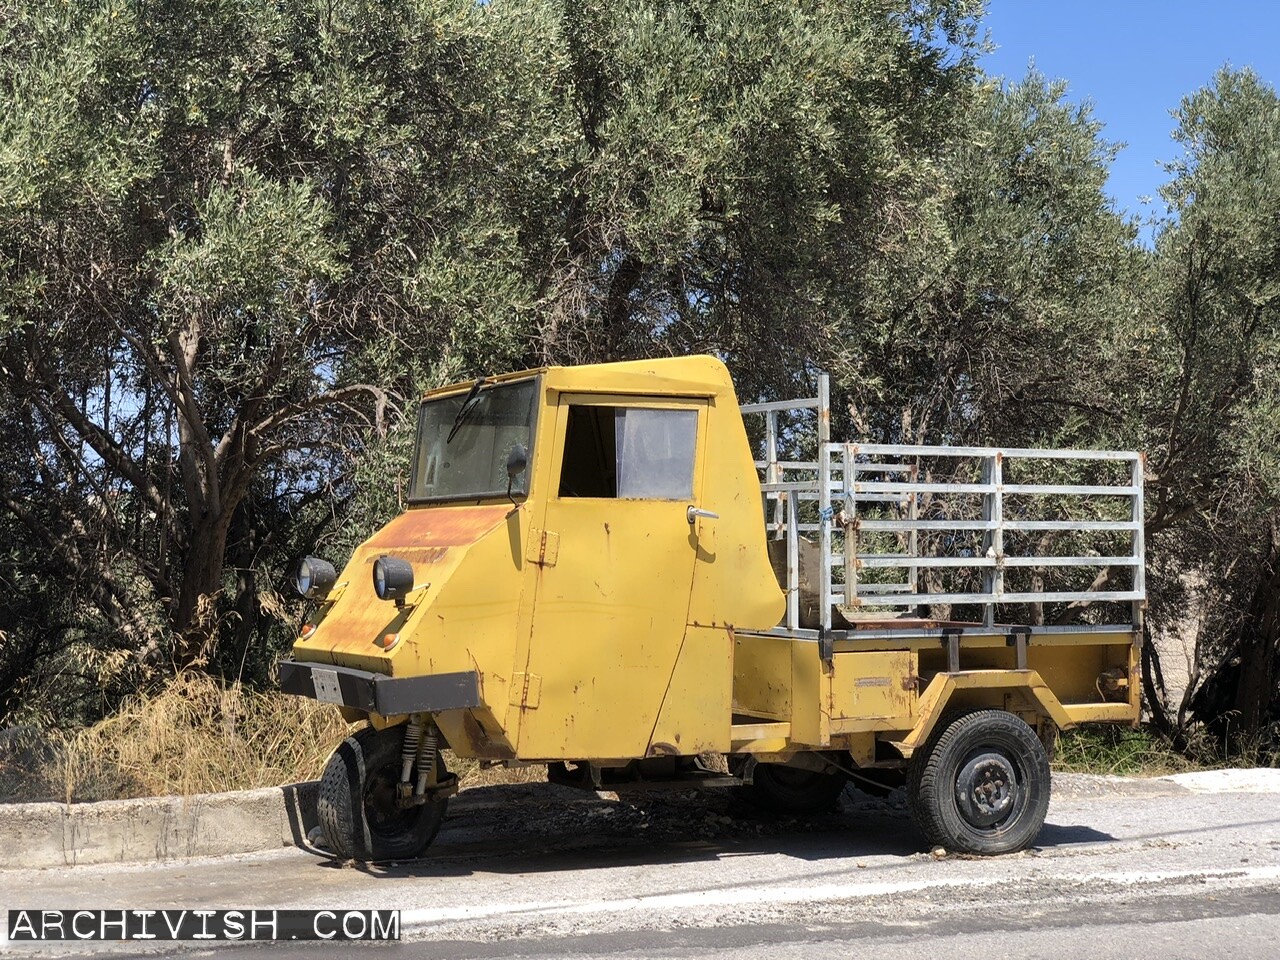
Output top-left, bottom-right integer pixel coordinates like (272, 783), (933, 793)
(909, 710), (1050, 855)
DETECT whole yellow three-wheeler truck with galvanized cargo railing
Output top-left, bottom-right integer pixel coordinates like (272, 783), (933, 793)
(280, 356), (1144, 860)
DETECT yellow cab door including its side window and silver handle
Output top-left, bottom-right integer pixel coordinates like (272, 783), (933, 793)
(508, 394), (708, 759)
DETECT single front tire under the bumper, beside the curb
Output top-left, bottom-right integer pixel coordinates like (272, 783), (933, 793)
(316, 724), (448, 860)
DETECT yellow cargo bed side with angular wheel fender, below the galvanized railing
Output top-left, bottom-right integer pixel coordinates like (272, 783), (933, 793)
(733, 627), (1139, 764)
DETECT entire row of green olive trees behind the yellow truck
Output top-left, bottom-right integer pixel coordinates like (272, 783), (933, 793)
(0, 0), (1280, 752)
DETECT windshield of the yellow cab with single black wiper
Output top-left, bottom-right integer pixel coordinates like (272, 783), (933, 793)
(410, 380), (538, 500)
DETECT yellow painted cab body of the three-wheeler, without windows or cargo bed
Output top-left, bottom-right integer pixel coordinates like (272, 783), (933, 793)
(293, 357), (783, 760)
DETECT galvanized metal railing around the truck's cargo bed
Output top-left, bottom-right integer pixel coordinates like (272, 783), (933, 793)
(742, 375), (1146, 634)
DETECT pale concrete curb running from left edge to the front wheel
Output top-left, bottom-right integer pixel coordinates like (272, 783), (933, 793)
(0, 781), (316, 869)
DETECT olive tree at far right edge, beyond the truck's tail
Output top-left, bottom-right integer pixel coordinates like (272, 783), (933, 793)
(1148, 70), (1280, 737)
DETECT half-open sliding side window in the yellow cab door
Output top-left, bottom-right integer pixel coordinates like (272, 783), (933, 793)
(559, 404), (698, 500)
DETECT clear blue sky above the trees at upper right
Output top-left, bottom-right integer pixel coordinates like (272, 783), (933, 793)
(982, 0), (1280, 236)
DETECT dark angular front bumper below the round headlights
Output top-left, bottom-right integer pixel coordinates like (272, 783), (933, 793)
(279, 660), (480, 717)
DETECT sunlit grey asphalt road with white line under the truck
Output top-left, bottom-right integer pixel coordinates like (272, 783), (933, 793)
(0, 771), (1280, 960)
